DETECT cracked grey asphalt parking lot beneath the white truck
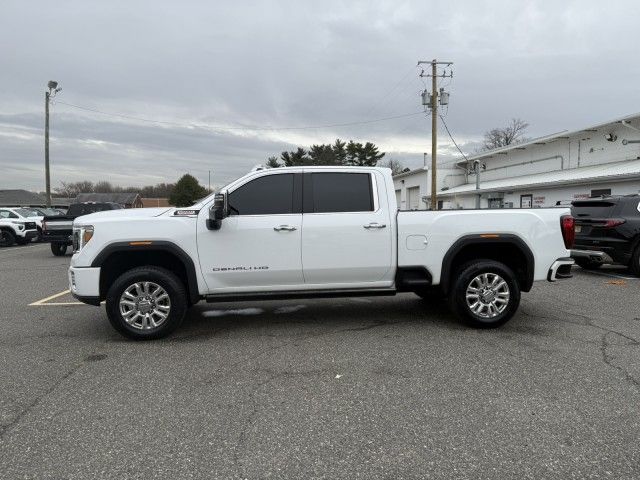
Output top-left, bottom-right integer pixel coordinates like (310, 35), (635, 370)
(0, 244), (640, 479)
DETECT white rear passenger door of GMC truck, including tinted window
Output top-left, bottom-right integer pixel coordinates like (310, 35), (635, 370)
(302, 171), (395, 288)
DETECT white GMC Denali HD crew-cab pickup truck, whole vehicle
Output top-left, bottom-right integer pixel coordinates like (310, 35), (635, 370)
(69, 167), (574, 339)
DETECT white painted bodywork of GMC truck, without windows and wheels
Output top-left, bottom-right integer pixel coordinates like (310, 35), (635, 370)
(71, 167), (569, 302)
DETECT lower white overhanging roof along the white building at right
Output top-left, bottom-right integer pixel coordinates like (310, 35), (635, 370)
(438, 160), (640, 197)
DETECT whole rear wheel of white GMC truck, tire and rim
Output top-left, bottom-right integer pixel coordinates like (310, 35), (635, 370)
(449, 260), (520, 328)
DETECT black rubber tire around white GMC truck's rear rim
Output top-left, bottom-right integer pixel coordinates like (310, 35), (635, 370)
(449, 259), (520, 328)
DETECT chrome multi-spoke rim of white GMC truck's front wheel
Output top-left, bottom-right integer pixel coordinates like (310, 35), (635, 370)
(119, 282), (171, 330)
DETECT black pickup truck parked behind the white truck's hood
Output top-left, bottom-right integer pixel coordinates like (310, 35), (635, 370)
(42, 202), (122, 257)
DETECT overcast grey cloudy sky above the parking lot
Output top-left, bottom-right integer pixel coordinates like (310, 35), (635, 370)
(0, 0), (640, 190)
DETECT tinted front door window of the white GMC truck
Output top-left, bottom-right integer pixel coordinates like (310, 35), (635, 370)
(228, 173), (294, 215)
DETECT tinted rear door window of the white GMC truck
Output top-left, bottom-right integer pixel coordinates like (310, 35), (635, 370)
(304, 172), (373, 213)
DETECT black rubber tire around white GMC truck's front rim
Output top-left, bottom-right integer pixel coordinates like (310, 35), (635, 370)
(106, 266), (189, 340)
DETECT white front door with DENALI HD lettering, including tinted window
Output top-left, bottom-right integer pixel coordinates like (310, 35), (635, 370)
(198, 171), (304, 293)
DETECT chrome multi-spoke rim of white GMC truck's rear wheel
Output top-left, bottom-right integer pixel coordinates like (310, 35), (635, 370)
(466, 273), (511, 318)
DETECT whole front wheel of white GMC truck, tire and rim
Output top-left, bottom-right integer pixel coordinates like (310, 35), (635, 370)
(106, 266), (188, 340)
